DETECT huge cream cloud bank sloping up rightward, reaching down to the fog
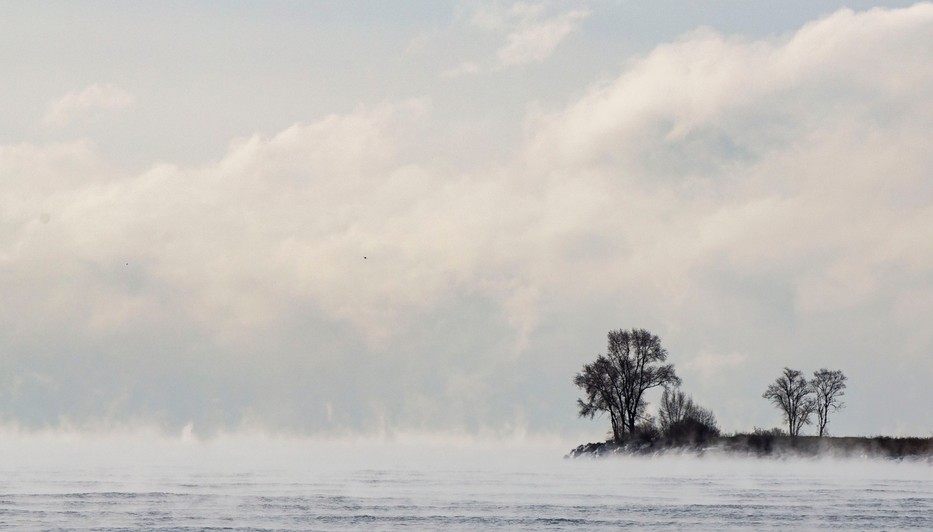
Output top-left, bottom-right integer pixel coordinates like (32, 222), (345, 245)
(0, 5), (933, 432)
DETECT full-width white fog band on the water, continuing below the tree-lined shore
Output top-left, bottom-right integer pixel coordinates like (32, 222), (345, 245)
(0, 428), (933, 479)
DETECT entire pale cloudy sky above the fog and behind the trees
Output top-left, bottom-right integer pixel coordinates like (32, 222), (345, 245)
(0, 0), (933, 441)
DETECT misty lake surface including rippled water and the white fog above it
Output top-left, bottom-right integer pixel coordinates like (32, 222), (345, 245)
(0, 434), (933, 530)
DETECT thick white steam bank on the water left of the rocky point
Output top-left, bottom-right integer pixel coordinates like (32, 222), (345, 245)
(0, 429), (572, 471)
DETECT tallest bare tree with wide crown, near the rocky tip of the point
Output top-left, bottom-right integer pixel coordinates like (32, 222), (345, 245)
(573, 329), (680, 441)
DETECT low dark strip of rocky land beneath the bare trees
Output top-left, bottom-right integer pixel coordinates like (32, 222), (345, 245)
(567, 433), (933, 460)
